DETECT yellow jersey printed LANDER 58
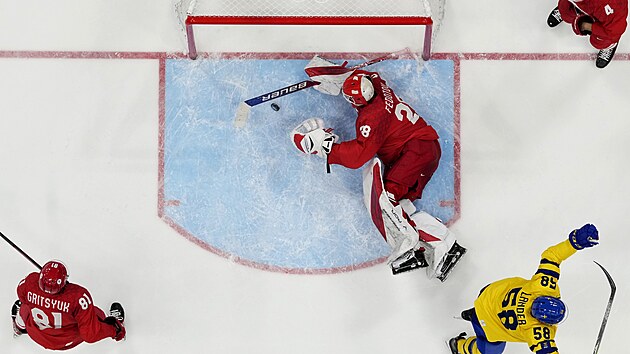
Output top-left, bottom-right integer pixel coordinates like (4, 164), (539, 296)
(475, 240), (576, 353)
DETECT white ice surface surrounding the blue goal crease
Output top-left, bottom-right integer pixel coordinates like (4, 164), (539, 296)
(0, 0), (630, 354)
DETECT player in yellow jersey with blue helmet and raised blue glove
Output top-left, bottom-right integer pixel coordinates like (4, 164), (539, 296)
(449, 224), (599, 354)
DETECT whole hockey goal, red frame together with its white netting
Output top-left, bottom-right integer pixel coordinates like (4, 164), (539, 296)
(175, 0), (445, 60)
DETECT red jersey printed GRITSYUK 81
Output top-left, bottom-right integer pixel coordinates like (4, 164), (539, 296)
(17, 273), (116, 350)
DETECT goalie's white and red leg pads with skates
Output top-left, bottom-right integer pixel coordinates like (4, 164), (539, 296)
(363, 158), (466, 281)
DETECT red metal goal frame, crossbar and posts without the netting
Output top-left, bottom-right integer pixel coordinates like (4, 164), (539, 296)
(185, 15), (433, 60)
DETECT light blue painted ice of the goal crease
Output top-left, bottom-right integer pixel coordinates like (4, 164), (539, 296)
(163, 57), (455, 270)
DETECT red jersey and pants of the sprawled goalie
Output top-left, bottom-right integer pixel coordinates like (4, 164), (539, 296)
(328, 70), (441, 201)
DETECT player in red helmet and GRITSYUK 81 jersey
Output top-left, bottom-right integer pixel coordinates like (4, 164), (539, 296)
(11, 261), (126, 350)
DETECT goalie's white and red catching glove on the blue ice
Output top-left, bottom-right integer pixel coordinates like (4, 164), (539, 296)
(291, 118), (338, 158)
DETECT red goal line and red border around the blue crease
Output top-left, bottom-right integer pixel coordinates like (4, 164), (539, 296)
(0, 51), (630, 274)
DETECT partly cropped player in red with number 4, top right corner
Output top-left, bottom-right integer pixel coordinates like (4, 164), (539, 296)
(547, 0), (628, 68)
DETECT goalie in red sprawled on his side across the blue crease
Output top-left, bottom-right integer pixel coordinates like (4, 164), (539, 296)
(291, 70), (466, 281)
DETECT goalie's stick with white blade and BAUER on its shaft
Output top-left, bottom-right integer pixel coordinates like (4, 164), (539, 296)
(234, 48), (411, 128)
